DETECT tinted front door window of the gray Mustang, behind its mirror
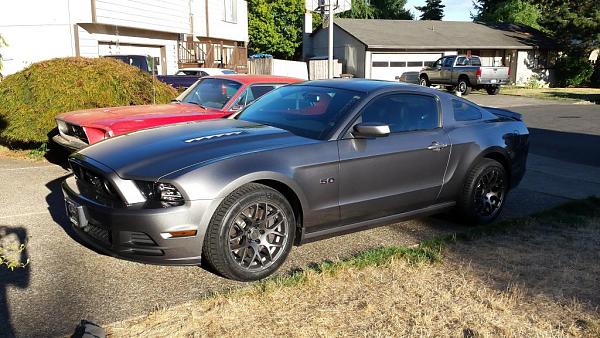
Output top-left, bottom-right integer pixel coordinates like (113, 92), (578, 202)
(361, 94), (439, 133)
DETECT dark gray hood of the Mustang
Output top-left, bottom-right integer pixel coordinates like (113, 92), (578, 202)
(76, 119), (316, 179)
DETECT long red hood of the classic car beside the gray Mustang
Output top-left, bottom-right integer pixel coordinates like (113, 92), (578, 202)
(57, 103), (231, 144)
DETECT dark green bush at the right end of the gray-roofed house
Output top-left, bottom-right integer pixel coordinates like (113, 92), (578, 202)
(556, 55), (594, 87)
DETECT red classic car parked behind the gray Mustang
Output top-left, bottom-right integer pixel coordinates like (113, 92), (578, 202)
(52, 74), (303, 150)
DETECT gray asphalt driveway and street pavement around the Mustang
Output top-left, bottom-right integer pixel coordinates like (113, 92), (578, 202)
(0, 95), (600, 337)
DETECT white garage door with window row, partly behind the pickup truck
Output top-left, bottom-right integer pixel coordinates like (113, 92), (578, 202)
(371, 52), (442, 81)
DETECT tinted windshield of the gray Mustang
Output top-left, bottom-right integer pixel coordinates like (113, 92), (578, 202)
(237, 86), (361, 140)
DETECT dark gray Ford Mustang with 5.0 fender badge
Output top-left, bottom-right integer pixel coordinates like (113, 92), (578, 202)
(63, 79), (529, 280)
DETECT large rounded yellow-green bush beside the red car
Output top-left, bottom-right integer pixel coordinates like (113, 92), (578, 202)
(0, 57), (177, 147)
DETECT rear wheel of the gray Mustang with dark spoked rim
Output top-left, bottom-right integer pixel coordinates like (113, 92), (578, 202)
(458, 158), (508, 224)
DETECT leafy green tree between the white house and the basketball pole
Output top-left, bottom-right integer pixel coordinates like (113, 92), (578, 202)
(248, 0), (321, 59)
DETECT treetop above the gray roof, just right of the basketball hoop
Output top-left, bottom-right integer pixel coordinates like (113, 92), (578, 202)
(338, 0), (414, 20)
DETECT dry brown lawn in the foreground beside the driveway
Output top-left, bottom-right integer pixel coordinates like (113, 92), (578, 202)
(107, 218), (600, 337)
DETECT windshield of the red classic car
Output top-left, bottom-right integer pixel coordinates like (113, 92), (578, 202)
(181, 78), (242, 109)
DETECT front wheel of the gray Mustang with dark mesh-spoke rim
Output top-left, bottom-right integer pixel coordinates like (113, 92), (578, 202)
(202, 183), (296, 281)
